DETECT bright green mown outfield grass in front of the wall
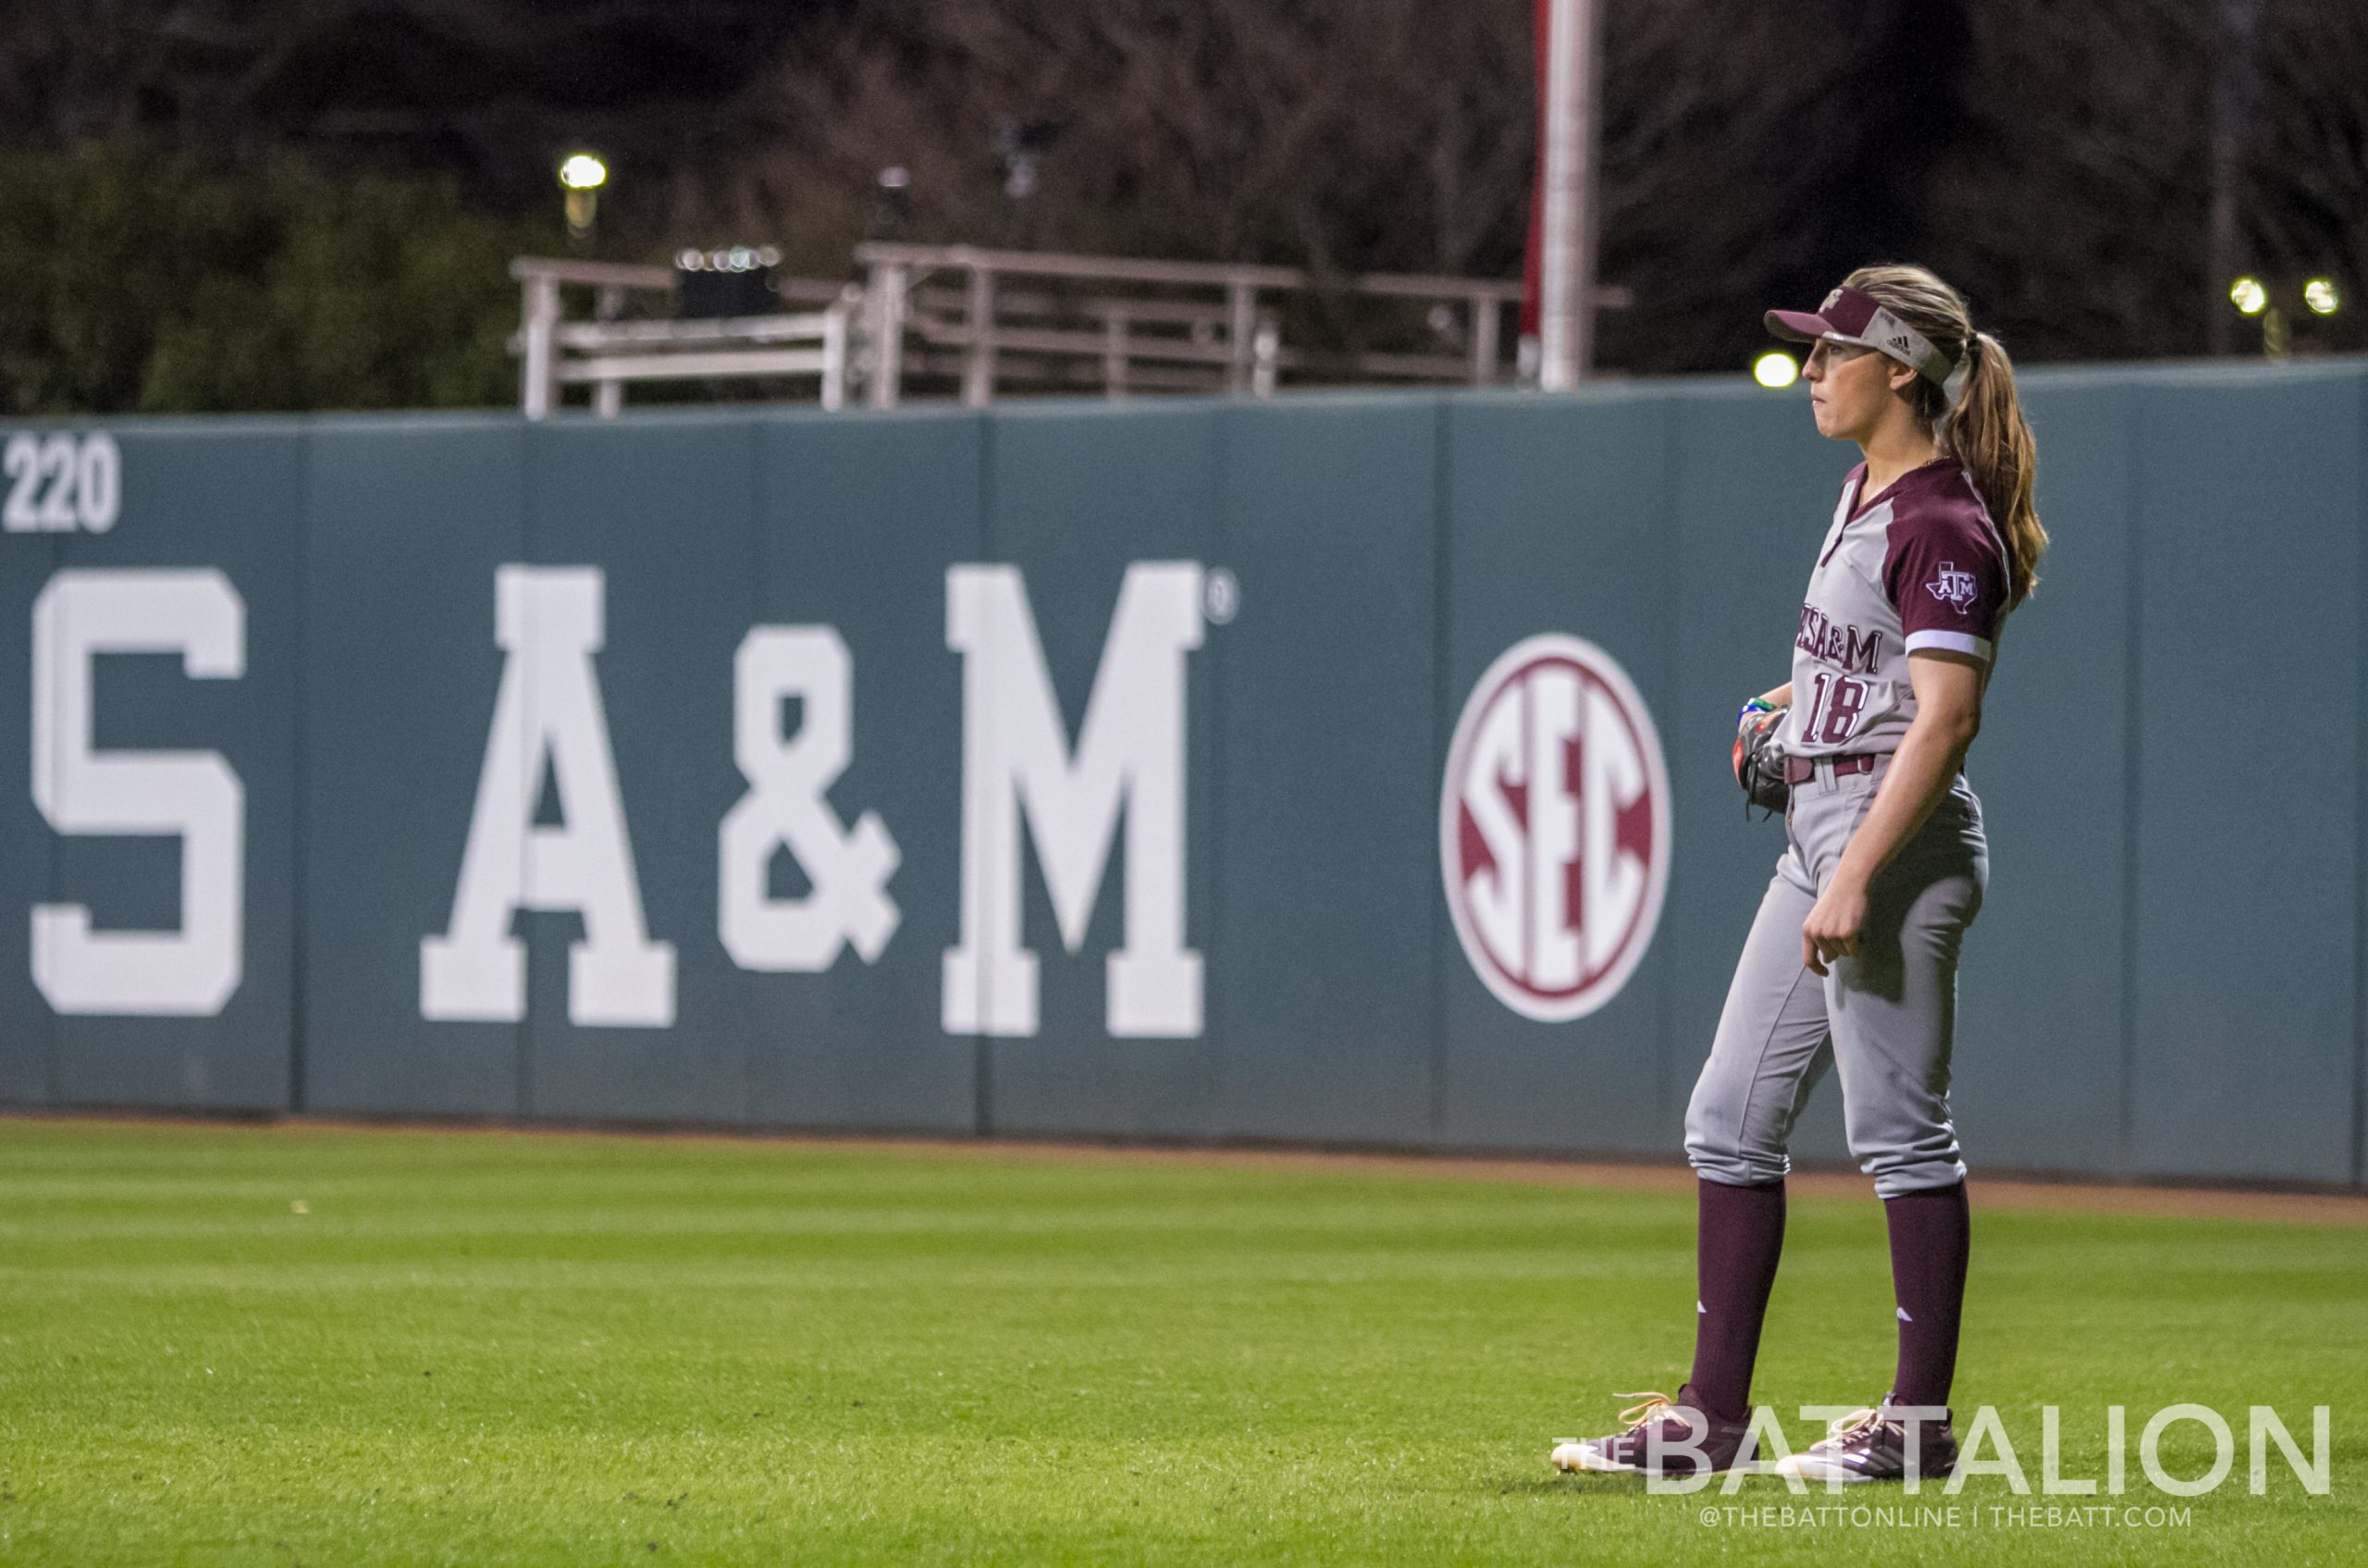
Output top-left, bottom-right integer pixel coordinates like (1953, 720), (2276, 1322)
(0, 1120), (2368, 1568)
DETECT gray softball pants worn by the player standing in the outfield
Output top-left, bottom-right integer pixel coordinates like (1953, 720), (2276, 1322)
(1686, 758), (1989, 1199)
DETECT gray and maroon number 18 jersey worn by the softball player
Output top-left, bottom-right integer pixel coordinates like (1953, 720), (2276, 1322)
(1781, 457), (2005, 756)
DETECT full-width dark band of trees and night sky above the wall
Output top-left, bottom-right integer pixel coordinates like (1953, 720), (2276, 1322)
(0, 0), (2368, 410)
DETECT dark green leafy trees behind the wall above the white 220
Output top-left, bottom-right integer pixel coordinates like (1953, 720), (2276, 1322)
(0, 142), (542, 413)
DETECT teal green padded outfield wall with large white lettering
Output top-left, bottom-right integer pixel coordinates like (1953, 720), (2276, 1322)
(0, 363), (2368, 1184)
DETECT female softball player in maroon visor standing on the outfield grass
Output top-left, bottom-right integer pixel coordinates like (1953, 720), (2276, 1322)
(1553, 265), (2048, 1480)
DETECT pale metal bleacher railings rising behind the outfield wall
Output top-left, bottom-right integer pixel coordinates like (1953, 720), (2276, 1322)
(509, 244), (1629, 419)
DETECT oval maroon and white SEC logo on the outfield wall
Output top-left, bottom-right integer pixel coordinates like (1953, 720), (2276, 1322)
(1439, 633), (1670, 1023)
